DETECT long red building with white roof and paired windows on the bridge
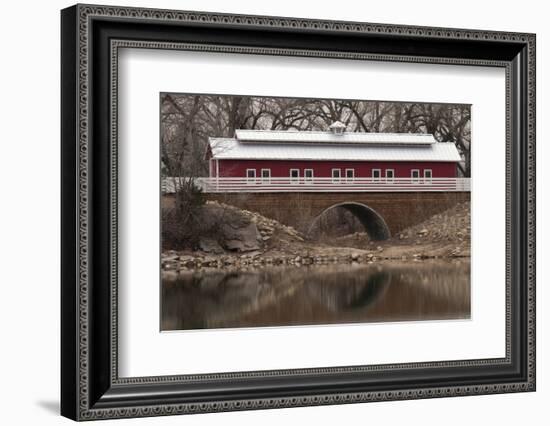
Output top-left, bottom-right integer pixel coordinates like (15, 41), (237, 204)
(207, 122), (461, 182)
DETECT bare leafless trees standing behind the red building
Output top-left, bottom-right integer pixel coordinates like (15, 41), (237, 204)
(161, 94), (471, 176)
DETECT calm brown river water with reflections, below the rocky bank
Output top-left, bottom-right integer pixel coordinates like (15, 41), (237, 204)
(161, 260), (470, 331)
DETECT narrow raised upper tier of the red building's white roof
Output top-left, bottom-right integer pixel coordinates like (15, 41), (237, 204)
(235, 130), (437, 145)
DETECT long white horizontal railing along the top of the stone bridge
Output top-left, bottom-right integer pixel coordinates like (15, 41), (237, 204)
(163, 177), (470, 193)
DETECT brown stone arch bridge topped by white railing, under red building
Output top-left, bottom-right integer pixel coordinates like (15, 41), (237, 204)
(162, 178), (470, 240)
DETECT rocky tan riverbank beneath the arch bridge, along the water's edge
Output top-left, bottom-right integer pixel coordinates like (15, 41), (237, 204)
(161, 202), (471, 273)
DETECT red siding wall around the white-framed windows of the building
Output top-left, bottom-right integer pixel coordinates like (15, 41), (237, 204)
(216, 160), (456, 178)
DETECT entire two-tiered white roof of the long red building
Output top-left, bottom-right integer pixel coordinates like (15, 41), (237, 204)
(209, 130), (461, 162)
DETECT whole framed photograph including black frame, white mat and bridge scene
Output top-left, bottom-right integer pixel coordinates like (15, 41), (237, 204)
(61, 5), (535, 420)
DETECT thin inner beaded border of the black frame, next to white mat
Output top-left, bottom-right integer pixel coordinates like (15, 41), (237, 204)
(110, 39), (511, 384)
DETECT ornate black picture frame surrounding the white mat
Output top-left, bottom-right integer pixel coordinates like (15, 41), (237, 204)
(61, 5), (536, 420)
